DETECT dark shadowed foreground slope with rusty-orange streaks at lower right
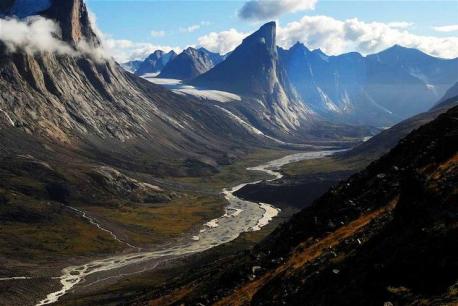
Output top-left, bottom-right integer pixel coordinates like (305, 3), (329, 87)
(144, 107), (458, 305)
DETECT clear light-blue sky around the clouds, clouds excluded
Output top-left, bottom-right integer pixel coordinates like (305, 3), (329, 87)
(87, 0), (458, 61)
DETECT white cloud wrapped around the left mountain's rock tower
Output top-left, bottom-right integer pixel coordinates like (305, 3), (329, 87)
(0, 16), (77, 54)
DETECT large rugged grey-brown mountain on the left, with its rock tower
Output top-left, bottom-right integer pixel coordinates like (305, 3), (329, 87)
(0, 0), (294, 222)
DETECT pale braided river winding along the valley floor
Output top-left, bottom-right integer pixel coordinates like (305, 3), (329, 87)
(37, 150), (340, 306)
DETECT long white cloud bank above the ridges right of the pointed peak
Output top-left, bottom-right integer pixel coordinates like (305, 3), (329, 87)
(277, 16), (458, 58)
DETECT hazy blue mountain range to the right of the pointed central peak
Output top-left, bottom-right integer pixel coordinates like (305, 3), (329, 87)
(279, 43), (458, 126)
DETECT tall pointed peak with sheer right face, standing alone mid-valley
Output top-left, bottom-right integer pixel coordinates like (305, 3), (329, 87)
(190, 22), (313, 131)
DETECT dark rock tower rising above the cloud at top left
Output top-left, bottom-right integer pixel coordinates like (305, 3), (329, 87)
(43, 0), (100, 47)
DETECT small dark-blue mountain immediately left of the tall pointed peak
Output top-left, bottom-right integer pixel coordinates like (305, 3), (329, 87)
(159, 47), (223, 80)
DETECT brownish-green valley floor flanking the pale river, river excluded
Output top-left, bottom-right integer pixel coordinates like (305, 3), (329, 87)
(0, 150), (346, 305)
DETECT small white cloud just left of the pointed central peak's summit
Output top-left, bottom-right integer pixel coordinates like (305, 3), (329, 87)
(198, 29), (248, 54)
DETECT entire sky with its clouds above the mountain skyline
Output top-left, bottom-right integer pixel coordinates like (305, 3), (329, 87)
(86, 0), (458, 62)
